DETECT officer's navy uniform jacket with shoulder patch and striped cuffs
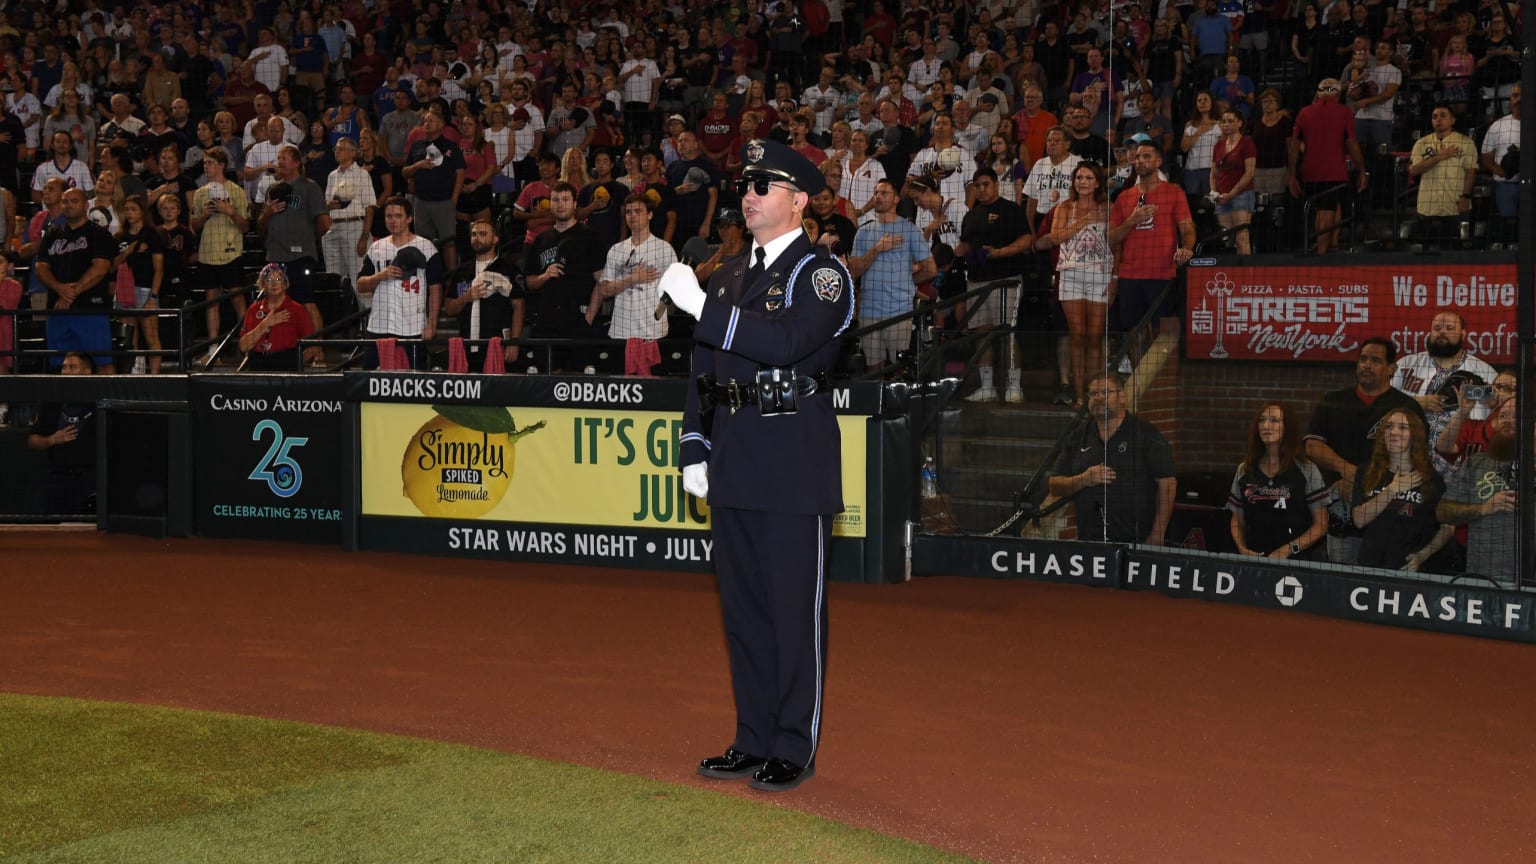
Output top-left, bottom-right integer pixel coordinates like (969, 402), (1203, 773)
(682, 234), (854, 513)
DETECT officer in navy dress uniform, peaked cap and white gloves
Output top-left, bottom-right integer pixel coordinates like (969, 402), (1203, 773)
(660, 138), (854, 792)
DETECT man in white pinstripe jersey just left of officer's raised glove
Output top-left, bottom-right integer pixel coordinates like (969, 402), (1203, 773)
(587, 192), (677, 378)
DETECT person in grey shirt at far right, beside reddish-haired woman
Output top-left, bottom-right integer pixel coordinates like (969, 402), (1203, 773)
(1435, 400), (1521, 581)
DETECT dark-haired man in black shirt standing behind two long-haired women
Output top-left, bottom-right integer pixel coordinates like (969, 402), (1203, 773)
(1306, 337), (1424, 563)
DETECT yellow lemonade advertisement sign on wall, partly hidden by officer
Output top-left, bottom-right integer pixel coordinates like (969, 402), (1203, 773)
(361, 403), (866, 537)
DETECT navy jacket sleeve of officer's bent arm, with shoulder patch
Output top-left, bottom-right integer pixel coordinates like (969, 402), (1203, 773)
(694, 257), (854, 366)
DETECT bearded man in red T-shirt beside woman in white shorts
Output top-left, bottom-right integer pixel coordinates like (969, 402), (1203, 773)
(1109, 141), (1195, 363)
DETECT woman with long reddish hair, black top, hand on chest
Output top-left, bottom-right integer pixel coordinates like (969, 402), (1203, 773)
(1344, 409), (1453, 573)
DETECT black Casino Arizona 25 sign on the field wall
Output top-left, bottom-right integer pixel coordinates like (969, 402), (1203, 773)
(189, 375), (350, 544)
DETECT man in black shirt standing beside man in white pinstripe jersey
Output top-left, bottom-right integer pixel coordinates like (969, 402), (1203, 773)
(522, 179), (602, 358)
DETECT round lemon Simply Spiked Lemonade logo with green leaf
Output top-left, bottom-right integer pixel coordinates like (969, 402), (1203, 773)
(399, 404), (544, 518)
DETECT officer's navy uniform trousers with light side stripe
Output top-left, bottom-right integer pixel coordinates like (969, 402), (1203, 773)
(710, 507), (833, 767)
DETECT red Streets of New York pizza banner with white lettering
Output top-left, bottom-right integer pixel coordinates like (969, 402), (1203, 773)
(1184, 258), (1516, 359)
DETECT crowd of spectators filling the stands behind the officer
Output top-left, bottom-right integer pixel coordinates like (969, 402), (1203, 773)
(0, 0), (1521, 578)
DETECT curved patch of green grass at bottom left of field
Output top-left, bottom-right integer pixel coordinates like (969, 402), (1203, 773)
(0, 695), (969, 864)
